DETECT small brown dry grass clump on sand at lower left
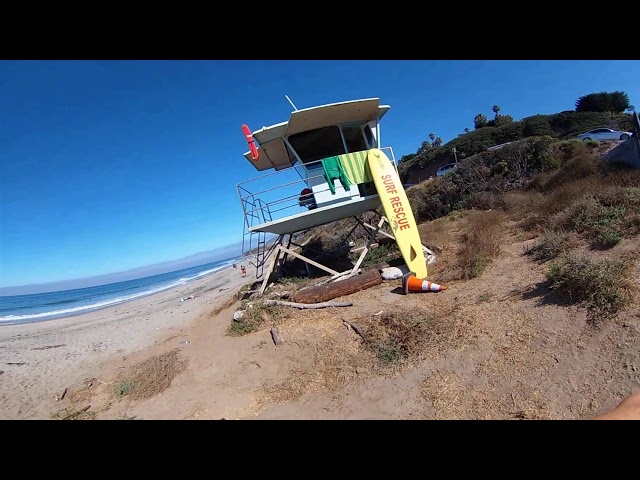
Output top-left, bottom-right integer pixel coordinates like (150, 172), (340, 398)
(113, 349), (187, 400)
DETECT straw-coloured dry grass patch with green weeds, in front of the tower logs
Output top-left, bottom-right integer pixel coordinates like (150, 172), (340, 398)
(258, 309), (463, 405)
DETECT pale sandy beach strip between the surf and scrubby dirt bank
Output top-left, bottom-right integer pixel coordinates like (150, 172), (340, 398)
(0, 266), (255, 419)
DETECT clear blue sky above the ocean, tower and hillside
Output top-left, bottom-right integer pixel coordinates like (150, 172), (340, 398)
(0, 61), (640, 286)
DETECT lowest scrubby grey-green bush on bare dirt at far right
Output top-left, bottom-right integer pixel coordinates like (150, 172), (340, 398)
(547, 254), (632, 318)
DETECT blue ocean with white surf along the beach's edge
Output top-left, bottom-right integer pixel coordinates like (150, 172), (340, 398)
(0, 258), (240, 325)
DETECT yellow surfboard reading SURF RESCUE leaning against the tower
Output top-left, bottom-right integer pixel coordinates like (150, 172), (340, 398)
(367, 148), (427, 279)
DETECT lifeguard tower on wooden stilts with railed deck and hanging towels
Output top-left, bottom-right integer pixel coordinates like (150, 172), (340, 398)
(237, 98), (397, 292)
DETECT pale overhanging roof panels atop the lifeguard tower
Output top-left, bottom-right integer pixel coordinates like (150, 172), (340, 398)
(244, 98), (391, 171)
